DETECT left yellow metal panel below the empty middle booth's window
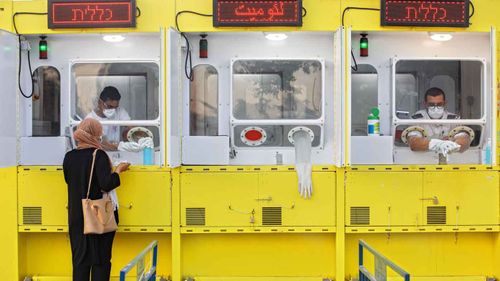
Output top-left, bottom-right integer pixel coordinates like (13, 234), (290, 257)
(181, 173), (259, 226)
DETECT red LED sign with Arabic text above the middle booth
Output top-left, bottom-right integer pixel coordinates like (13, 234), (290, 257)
(213, 0), (302, 26)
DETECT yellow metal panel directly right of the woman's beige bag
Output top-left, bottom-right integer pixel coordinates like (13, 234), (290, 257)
(117, 171), (171, 226)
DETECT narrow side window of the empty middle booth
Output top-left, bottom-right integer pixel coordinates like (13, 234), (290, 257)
(189, 65), (219, 136)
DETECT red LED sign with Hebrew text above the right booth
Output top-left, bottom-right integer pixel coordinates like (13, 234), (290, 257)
(380, 0), (469, 27)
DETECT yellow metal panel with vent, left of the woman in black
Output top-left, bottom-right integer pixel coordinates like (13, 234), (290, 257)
(18, 167), (68, 226)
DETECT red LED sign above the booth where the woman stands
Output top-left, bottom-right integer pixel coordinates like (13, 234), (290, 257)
(48, 0), (136, 29)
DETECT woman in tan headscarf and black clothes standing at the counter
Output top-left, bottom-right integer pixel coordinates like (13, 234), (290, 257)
(63, 118), (130, 281)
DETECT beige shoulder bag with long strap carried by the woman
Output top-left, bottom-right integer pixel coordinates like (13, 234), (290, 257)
(82, 149), (118, 234)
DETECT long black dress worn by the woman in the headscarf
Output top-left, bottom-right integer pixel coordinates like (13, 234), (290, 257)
(63, 148), (120, 268)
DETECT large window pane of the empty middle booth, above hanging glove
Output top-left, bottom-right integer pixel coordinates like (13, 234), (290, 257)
(232, 60), (323, 120)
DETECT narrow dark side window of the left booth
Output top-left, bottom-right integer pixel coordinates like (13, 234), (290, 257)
(32, 66), (61, 136)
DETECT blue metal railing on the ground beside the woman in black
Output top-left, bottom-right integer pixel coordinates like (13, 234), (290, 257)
(120, 240), (158, 281)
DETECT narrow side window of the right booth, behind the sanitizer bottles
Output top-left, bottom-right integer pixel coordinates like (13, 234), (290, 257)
(351, 64), (378, 136)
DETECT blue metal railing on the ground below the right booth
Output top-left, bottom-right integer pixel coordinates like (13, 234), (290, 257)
(359, 240), (410, 281)
